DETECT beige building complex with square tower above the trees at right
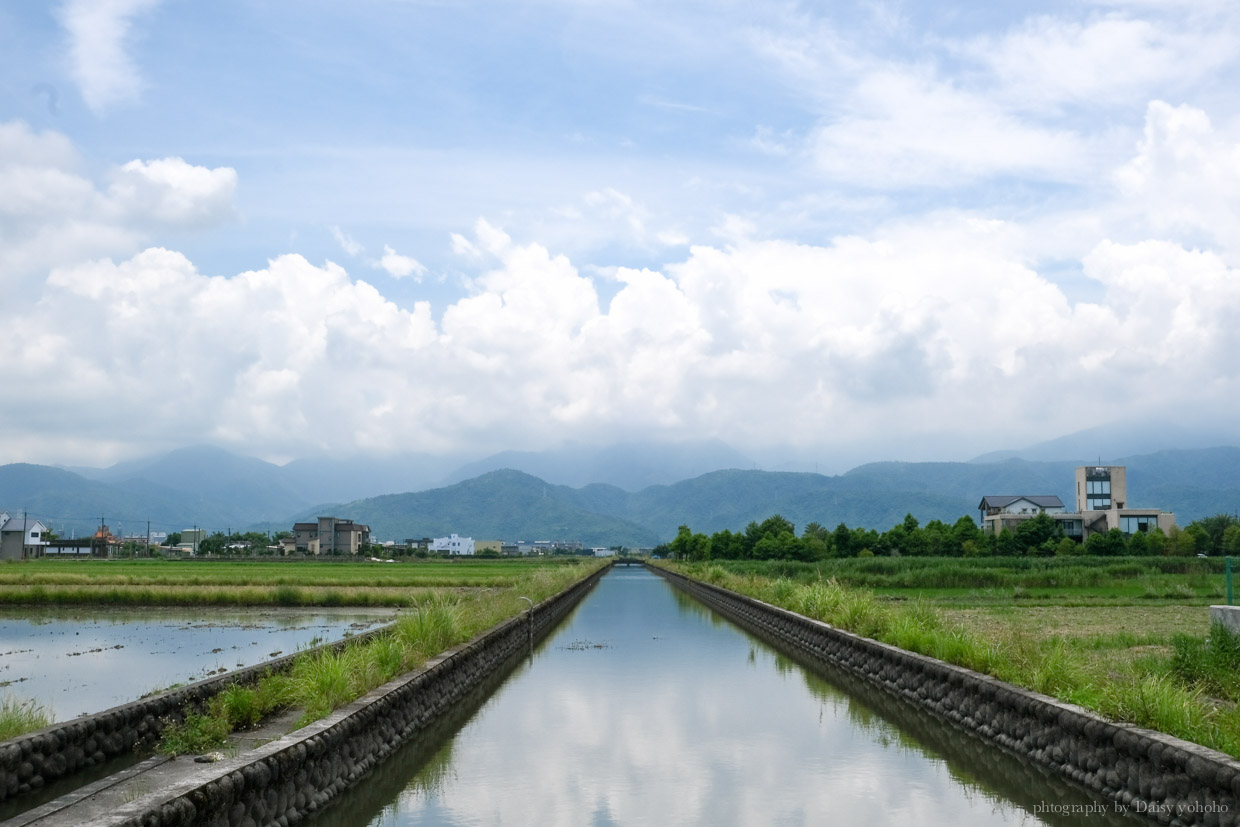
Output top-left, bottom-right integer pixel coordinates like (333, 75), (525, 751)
(977, 465), (1176, 542)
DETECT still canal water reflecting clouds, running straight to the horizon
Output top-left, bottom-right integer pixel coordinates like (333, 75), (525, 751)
(310, 570), (1127, 827)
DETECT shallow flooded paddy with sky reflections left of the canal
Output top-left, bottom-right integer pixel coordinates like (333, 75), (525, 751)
(0, 608), (394, 720)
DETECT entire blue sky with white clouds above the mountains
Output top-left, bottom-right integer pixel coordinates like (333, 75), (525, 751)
(0, 0), (1240, 466)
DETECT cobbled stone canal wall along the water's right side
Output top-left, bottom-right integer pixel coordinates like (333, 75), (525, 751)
(650, 567), (1240, 827)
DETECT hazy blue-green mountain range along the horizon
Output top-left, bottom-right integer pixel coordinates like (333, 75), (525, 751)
(0, 443), (1240, 546)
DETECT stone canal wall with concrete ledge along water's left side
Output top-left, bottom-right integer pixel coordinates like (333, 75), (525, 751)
(13, 567), (610, 827)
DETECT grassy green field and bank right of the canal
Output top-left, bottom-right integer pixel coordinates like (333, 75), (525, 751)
(670, 560), (1240, 758)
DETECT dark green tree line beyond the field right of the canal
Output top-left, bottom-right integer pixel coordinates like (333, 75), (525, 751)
(655, 513), (1240, 562)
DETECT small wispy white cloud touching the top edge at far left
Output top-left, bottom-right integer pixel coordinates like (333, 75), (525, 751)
(58, 0), (159, 113)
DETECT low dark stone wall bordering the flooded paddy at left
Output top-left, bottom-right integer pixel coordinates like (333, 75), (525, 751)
(0, 626), (387, 801)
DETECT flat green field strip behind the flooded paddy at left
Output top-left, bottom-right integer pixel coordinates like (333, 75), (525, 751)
(0, 558), (590, 606)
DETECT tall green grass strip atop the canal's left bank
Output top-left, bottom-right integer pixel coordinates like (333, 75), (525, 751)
(159, 559), (604, 755)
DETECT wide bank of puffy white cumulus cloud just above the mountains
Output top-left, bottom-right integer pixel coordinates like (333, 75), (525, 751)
(9, 202), (1240, 466)
